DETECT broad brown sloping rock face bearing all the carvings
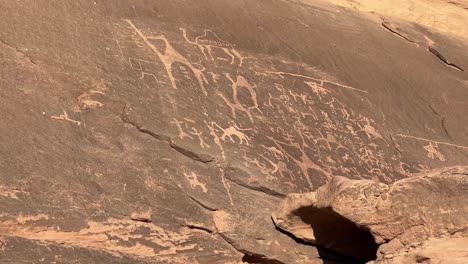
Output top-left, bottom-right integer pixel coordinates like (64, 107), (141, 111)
(0, 0), (468, 264)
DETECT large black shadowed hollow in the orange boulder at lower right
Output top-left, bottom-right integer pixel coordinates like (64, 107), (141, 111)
(293, 206), (379, 262)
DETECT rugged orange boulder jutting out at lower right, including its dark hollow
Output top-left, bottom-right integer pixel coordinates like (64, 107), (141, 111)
(273, 167), (468, 263)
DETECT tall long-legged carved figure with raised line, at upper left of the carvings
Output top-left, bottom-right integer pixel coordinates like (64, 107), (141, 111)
(124, 19), (208, 96)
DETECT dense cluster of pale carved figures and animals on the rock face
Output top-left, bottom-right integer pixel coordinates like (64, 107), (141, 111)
(118, 20), (416, 190)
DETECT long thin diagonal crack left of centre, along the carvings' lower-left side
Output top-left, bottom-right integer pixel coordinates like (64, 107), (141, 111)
(120, 106), (215, 163)
